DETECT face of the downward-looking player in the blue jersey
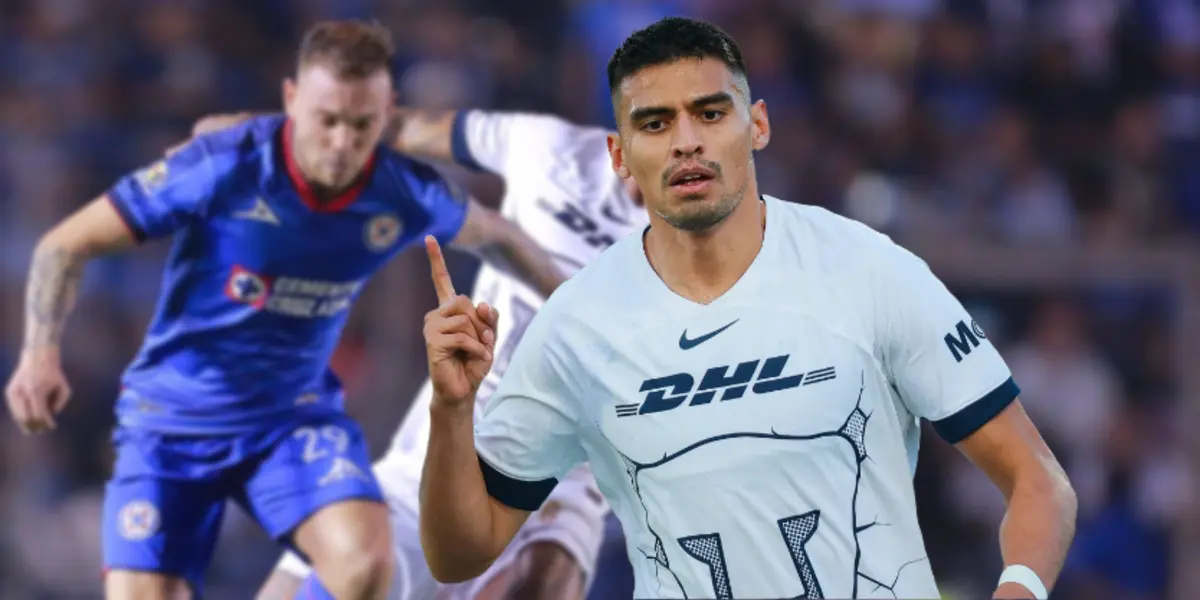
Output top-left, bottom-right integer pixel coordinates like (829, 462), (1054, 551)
(283, 62), (394, 188)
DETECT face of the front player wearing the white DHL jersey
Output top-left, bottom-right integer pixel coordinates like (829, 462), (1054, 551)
(608, 59), (769, 232)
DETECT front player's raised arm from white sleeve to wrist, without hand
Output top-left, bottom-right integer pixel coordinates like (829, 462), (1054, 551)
(420, 288), (586, 583)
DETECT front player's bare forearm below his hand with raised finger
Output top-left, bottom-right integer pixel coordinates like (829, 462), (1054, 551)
(420, 398), (523, 583)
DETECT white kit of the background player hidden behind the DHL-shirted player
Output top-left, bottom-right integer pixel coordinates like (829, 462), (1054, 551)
(277, 110), (648, 600)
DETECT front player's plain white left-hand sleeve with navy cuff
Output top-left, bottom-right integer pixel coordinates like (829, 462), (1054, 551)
(475, 304), (586, 511)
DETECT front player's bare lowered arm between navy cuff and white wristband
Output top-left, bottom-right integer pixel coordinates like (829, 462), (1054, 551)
(959, 402), (1076, 598)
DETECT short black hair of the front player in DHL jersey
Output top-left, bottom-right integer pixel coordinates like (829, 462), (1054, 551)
(608, 17), (746, 95)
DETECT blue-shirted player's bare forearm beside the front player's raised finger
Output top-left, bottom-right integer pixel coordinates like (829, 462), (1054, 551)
(454, 200), (565, 298)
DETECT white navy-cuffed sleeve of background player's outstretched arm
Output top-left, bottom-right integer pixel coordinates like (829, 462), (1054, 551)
(450, 110), (581, 176)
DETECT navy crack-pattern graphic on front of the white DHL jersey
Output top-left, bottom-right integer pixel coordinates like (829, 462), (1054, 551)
(613, 372), (926, 599)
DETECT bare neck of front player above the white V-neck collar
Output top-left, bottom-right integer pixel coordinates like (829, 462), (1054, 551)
(646, 192), (767, 304)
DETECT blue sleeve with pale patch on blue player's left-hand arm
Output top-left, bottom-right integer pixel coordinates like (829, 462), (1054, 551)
(108, 142), (217, 242)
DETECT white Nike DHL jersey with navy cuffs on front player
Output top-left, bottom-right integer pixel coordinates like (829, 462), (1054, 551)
(475, 198), (1018, 599)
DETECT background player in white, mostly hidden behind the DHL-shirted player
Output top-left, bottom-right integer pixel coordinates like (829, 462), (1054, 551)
(194, 108), (648, 600)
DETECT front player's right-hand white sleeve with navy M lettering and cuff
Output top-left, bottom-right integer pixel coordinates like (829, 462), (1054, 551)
(871, 241), (1020, 444)
